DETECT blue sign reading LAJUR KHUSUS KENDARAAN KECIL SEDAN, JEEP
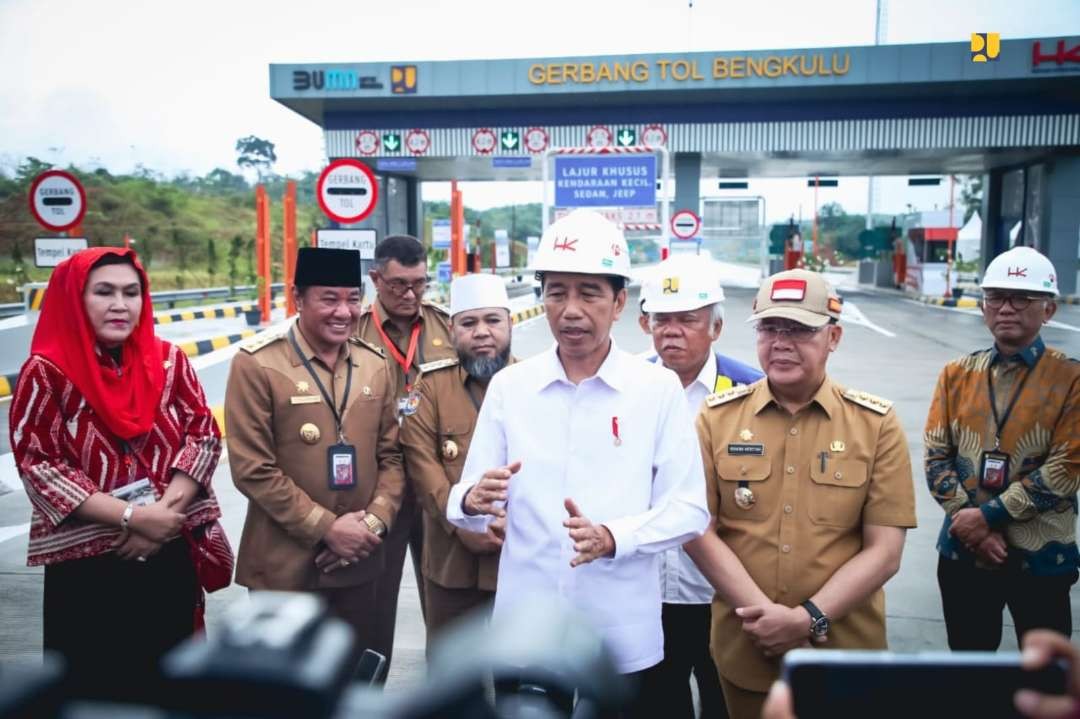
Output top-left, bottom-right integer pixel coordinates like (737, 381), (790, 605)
(555, 154), (657, 207)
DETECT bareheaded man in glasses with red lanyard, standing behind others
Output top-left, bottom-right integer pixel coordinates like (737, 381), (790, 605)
(355, 235), (457, 666)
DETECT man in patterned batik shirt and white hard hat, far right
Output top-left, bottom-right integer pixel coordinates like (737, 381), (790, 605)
(924, 247), (1080, 651)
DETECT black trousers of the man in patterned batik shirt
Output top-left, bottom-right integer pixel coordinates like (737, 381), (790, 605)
(937, 550), (1077, 652)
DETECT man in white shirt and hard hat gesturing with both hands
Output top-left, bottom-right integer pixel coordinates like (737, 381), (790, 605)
(447, 209), (708, 717)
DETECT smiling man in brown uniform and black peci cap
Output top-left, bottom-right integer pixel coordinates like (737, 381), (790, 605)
(225, 247), (405, 654)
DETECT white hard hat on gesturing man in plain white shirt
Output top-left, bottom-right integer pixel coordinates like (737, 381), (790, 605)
(532, 209), (631, 280)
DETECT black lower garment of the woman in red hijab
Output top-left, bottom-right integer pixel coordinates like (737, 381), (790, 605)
(42, 539), (202, 700)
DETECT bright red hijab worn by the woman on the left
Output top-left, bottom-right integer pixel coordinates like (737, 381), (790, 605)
(30, 247), (165, 439)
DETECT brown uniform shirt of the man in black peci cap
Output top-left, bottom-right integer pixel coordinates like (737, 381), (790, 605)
(225, 325), (405, 591)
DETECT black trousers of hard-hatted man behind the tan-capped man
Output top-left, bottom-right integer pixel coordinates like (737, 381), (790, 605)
(658, 605), (728, 719)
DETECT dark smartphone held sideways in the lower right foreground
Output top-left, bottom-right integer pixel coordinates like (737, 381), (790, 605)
(783, 649), (1066, 719)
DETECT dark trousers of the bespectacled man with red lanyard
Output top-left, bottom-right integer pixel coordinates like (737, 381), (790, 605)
(372, 488), (426, 674)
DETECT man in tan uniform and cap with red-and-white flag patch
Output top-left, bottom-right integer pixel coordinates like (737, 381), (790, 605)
(687, 270), (915, 719)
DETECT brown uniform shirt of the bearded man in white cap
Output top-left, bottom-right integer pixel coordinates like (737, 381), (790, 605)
(401, 361), (514, 592)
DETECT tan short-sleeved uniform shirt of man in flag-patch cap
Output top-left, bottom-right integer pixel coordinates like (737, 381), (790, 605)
(698, 378), (916, 691)
